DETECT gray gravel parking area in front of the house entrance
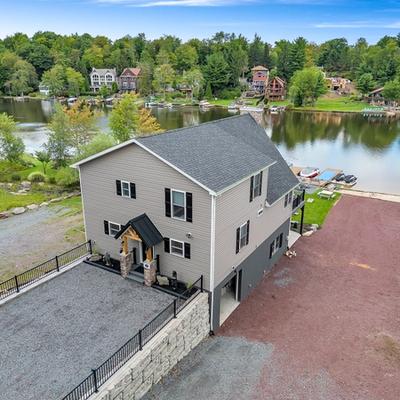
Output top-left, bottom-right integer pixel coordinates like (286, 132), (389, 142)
(0, 264), (173, 400)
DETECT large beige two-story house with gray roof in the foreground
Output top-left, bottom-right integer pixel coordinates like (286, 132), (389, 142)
(75, 115), (298, 330)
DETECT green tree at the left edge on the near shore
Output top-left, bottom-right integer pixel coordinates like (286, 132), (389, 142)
(0, 113), (25, 162)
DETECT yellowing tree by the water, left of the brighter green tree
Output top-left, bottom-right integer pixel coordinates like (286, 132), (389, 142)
(63, 101), (97, 153)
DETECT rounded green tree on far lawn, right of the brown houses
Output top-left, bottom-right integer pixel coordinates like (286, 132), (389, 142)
(289, 67), (327, 107)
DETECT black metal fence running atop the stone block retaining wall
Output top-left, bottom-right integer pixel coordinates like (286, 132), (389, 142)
(62, 275), (203, 400)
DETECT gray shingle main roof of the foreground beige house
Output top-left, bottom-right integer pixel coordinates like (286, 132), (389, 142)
(138, 114), (298, 200)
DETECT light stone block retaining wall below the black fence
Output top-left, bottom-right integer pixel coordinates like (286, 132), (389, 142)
(90, 293), (210, 400)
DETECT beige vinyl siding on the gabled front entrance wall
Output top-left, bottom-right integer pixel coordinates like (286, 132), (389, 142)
(80, 144), (211, 288)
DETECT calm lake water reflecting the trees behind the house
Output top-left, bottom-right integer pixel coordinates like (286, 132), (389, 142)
(0, 99), (400, 194)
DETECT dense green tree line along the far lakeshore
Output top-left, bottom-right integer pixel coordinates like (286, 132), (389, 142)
(0, 32), (400, 98)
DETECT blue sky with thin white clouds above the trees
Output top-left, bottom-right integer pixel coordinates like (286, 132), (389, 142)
(0, 0), (400, 43)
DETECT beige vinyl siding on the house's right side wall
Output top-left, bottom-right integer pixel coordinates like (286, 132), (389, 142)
(214, 169), (291, 287)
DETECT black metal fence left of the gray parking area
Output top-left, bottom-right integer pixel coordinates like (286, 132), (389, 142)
(0, 240), (92, 300)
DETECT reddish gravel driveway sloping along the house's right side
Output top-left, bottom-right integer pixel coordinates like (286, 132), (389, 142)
(146, 196), (400, 400)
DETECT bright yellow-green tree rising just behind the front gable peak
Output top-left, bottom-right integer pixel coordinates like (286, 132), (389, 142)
(109, 93), (139, 143)
